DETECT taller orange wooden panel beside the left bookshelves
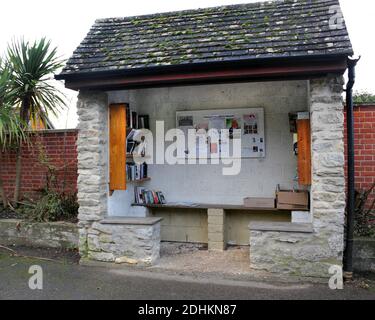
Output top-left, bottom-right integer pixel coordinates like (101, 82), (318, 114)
(109, 104), (126, 192)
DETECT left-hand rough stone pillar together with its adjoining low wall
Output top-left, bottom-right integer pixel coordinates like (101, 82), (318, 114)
(77, 91), (161, 265)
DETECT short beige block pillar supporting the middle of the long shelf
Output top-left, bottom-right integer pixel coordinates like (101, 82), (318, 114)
(207, 209), (227, 251)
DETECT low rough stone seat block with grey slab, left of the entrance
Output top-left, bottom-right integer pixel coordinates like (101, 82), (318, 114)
(87, 217), (162, 265)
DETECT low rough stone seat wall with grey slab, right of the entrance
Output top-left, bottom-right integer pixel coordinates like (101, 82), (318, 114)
(249, 222), (336, 278)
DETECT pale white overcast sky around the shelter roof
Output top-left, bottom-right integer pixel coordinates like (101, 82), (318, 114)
(0, 0), (375, 129)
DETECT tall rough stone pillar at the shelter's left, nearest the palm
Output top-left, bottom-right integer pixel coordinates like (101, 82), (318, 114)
(77, 91), (108, 257)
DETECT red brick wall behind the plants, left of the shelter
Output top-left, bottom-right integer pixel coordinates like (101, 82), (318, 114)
(0, 130), (77, 198)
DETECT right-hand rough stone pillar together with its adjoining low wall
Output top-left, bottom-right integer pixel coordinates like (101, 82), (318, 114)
(250, 76), (345, 277)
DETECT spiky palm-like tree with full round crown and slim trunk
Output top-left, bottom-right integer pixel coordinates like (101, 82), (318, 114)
(7, 38), (65, 203)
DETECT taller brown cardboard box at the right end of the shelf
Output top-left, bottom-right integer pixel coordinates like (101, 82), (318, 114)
(276, 190), (309, 211)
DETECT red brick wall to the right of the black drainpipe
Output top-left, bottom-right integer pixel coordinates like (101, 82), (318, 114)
(345, 105), (375, 210)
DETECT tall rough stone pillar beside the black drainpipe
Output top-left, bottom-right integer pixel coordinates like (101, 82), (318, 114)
(310, 76), (346, 272)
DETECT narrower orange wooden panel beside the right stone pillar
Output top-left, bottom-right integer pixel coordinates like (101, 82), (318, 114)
(297, 119), (311, 186)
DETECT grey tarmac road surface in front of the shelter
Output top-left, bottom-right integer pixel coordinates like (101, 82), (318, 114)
(0, 248), (375, 300)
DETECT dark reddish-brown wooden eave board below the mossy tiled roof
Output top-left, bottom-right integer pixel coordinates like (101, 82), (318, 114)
(65, 59), (347, 90)
